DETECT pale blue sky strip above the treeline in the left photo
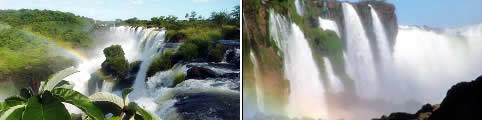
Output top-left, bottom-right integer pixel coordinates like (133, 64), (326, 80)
(0, 0), (240, 20)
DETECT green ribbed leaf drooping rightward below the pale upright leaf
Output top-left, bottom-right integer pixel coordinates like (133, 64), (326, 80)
(52, 88), (104, 120)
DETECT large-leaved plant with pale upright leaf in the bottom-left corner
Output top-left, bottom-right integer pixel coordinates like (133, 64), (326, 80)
(0, 67), (104, 120)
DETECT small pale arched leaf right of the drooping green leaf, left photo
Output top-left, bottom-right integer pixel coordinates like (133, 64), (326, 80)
(89, 92), (125, 108)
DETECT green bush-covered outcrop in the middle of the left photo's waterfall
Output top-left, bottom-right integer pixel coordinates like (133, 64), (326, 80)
(102, 45), (129, 78)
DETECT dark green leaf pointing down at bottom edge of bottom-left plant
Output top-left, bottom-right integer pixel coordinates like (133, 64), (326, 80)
(22, 96), (44, 120)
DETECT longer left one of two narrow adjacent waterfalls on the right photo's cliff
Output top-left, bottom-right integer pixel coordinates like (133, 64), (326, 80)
(342, 3), (378, 98)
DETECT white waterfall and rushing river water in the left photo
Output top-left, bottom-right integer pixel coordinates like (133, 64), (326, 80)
(62, 26), (240, 119)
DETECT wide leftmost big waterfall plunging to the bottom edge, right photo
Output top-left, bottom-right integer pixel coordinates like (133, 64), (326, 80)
(270, 11), (327, 118)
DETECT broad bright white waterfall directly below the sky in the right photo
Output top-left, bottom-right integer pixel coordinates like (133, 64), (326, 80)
(393, 24), (482, 103)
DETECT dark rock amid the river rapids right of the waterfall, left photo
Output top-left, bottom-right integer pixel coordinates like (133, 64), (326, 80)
(186, 66), (216, 79)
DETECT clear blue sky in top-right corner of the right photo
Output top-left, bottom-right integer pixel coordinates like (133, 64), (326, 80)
(349, 0), (482, 27)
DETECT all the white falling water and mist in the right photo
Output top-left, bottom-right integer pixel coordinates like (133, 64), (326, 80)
(250, 3), (482, 119)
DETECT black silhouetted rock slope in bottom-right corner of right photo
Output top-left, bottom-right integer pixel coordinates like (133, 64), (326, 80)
(374, 76), (482, 120)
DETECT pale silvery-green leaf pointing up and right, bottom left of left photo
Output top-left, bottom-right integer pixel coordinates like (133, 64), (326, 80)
(40, 67), (79, 92)
